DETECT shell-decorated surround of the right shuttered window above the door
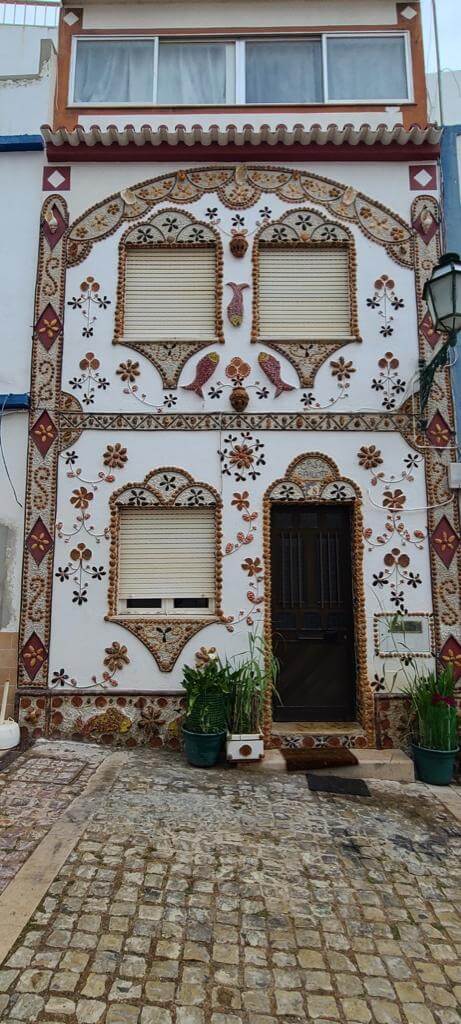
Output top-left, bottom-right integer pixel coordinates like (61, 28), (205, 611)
(251, 207), (362, 387)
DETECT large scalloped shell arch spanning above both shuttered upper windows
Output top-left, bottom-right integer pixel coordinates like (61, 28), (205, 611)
(68, 164), (413, 267)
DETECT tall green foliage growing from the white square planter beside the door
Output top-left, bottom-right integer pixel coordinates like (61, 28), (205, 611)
(228, 633), (279, 734)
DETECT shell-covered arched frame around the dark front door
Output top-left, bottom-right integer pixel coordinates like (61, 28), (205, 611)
(262, 452), (376, 746)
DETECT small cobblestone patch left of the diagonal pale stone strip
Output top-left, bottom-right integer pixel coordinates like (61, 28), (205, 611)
(0, 741), (108, 893)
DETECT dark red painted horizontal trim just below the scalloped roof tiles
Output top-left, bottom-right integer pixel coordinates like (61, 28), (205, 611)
(46, 142), (441, 164)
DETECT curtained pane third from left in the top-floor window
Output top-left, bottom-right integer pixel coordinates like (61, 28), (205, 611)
(245, 39), (323, 103)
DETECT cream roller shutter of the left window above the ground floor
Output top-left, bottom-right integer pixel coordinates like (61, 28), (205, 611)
(123, 247), (216, 341)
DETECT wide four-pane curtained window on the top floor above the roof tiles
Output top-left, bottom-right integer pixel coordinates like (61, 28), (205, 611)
(71, 32), (412, 106)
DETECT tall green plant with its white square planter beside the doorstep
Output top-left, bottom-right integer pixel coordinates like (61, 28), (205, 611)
(225, 634), (279, 761)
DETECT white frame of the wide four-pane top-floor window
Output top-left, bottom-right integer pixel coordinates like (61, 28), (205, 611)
(68, 30), (415, 110)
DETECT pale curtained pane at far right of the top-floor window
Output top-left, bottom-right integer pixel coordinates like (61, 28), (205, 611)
(327, 36), (408, 99)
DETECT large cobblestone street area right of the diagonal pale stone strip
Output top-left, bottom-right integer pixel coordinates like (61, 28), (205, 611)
(0, 751), (461, 1024)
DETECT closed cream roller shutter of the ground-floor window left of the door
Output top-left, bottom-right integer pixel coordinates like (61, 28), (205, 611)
(119, 508), (215, 599)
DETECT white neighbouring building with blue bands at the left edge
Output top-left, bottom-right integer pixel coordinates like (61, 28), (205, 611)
(0, 3), (58, 720)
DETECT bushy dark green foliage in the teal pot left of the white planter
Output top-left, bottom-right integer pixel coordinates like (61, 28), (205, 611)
(182, 657), (237, 733)
